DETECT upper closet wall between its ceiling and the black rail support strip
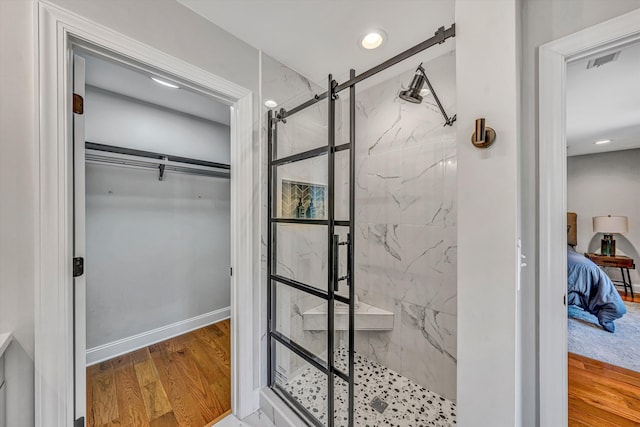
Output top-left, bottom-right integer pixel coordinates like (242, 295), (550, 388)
(85, 86), (231, 164)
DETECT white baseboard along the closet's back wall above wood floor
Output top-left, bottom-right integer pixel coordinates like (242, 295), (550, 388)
(87, 307), (231, 366)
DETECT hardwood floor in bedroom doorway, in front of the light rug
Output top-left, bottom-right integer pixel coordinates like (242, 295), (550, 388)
(569, 353), (640, 427)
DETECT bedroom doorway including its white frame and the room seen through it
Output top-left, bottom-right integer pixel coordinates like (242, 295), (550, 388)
(539, 10), (640, 425)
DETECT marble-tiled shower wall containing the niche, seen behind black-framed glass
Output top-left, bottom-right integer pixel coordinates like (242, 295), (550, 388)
(260, 54), (327, 377)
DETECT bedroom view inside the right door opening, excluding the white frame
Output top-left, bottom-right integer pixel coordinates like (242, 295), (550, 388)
(566, 38), (640, 425)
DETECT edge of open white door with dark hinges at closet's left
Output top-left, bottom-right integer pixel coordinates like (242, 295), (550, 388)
(73, 55), (87, 420)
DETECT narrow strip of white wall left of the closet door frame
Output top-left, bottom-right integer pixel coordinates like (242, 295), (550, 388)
(0, 0), (37, 426)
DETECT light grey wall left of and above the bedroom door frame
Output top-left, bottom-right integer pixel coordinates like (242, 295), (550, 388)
(520, 0), (640, 426)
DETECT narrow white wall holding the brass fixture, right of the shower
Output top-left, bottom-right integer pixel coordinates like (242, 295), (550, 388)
(455, 0), (520, 427)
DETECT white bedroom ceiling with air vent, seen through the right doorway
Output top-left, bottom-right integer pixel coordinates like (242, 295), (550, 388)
(567, 43), (640, 156)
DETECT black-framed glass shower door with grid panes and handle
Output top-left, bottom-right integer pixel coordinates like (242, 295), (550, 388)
(267, 76), (355, 426)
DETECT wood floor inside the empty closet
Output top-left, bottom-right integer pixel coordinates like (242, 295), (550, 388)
(87, 320), (231, 427)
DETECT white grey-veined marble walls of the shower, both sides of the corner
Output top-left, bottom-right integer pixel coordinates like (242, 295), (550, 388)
(260, 53), (457, 400)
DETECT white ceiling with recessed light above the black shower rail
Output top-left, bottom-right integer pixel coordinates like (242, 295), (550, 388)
(178, 0), (454, 87)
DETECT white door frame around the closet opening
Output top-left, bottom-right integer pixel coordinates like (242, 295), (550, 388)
(34, 1), (259, 427)
